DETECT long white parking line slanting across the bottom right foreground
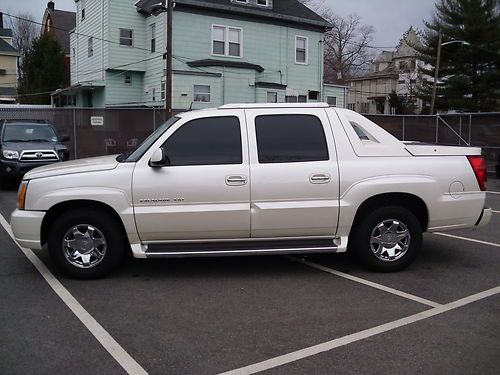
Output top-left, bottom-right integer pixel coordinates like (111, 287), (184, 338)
(220, 286), (500, 375)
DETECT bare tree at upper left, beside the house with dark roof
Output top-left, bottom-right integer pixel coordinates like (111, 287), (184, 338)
(9, 13), (40, 68)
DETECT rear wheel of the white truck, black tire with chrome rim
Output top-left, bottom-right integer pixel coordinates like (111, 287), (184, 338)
(349, 206), (422, 272)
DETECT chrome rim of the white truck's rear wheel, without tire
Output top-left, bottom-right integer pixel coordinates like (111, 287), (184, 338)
(370, 219), (411, 262)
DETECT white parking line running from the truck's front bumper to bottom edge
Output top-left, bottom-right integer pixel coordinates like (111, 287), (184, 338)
(0, 214), (147, 375)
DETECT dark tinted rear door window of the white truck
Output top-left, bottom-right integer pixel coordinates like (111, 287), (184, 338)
(255, 115), (328, 163)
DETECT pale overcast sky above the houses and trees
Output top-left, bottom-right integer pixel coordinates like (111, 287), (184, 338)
(0, 0), (435, 47)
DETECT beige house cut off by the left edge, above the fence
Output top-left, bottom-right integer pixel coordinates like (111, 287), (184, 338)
(0, 13), (19, 104)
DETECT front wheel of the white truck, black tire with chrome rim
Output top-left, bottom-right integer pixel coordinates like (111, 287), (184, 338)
(48, 209), (126, 279)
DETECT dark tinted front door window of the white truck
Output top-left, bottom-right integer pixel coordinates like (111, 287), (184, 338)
(162, 116), (242, 166)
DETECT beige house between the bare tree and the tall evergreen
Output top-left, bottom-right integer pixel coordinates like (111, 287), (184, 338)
(347, 28), (424, 114)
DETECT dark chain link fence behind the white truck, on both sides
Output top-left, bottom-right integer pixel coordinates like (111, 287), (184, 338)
(0, 108), (500, 166)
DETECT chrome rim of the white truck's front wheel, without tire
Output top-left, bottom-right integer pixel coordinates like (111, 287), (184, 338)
(62, 224), (107, 268)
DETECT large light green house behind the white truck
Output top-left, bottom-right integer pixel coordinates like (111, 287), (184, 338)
(60, 0), (345, 110)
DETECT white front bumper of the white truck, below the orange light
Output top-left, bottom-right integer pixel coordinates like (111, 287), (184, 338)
(10, 209), (45, 250)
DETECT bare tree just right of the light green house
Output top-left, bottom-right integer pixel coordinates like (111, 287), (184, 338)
(322, 9), (375, 82)
